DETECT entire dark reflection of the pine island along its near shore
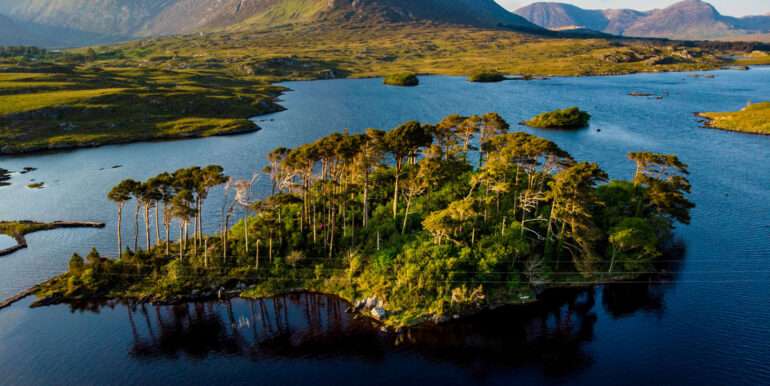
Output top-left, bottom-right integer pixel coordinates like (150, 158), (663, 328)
(94, 284), (664, 380)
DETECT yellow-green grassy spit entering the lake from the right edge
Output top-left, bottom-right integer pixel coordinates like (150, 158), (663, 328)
(696, 102), (770, 135)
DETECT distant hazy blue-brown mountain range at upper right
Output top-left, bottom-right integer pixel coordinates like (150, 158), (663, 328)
(514, 0), (770, 40)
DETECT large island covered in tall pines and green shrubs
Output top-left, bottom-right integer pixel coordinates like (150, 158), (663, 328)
(33, 113), (694, 328)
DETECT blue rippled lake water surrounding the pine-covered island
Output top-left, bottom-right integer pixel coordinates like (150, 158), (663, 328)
(0, 68), (770, 384)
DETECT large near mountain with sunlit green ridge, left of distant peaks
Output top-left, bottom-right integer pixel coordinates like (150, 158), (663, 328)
(0, 0), (539, 44)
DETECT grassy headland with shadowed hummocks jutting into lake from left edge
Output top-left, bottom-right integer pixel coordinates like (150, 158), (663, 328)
(0, 63), (283, 153)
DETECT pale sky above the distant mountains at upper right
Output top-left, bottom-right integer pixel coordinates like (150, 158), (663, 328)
(496, 0), (770, 16)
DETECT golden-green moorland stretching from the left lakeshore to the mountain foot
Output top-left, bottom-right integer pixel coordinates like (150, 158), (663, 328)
(0, 20), (734, 154)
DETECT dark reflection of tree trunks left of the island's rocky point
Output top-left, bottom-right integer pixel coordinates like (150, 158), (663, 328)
(123, 294), (382, 361)
